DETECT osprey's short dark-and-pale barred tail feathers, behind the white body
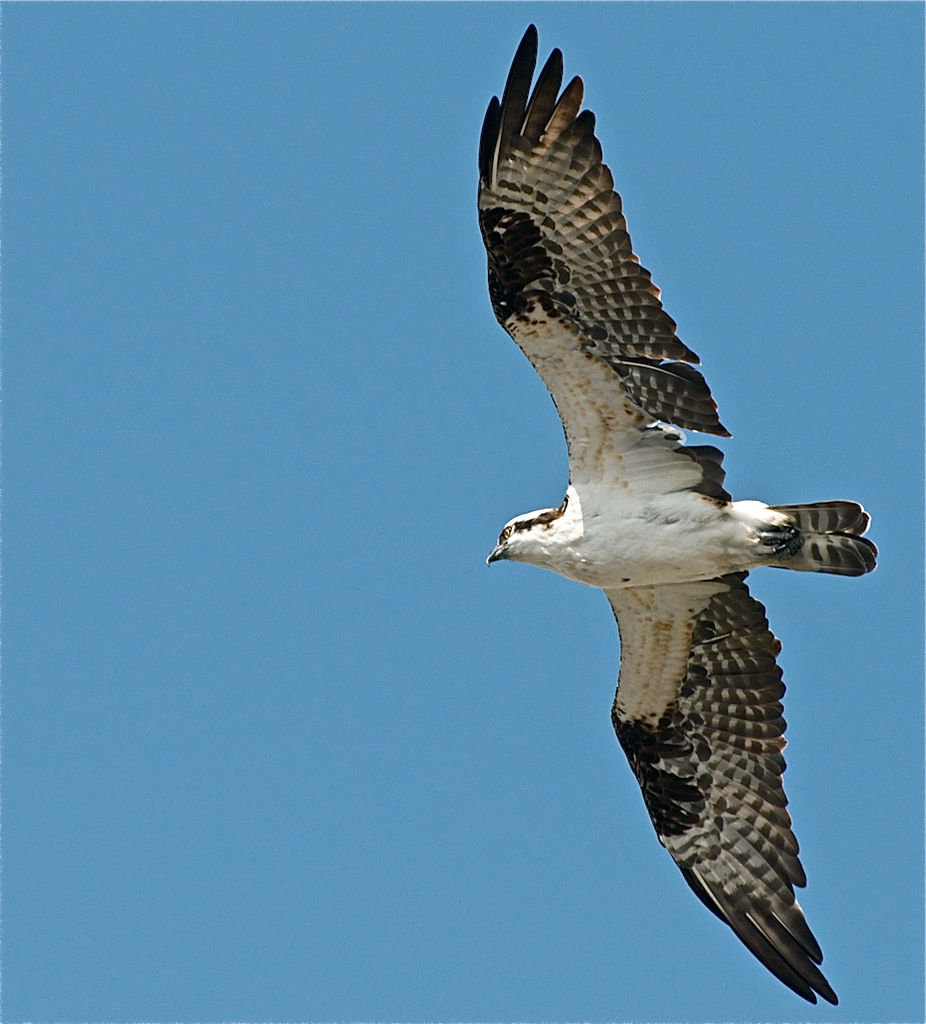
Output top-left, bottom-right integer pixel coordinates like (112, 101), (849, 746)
(771, 502), (878, 575)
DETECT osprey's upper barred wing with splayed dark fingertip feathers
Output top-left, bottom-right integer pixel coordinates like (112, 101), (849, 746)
(479, 26), (729, 485)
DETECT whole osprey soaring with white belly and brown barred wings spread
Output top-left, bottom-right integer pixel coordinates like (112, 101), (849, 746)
(478, 26), (877, 1004)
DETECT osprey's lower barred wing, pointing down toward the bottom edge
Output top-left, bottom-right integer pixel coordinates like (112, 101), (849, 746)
(607, 572), (837, 1004)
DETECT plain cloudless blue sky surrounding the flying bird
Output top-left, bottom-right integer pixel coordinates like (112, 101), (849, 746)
(2, 3), (924, 1022)
